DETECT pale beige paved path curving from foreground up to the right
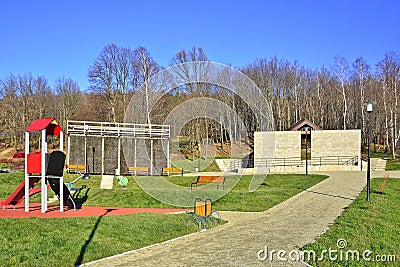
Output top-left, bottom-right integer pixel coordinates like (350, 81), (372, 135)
(87, 172), (376, 266)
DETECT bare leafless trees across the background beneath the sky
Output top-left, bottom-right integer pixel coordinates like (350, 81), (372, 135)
(0, 44), (400, 157)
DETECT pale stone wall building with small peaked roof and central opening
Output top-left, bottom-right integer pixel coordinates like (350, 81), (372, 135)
(254, 119), (361, 173)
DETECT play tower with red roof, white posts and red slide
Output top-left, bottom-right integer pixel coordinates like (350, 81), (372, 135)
(1, 118), (76, 213)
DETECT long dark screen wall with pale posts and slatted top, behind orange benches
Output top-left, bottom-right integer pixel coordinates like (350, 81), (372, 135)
(67, 121), (170, 176)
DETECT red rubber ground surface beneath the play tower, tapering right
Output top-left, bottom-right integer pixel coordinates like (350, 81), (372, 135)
(0, 203), (186, 218)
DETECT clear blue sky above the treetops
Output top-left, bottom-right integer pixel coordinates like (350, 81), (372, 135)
(0, 0), (400, 90)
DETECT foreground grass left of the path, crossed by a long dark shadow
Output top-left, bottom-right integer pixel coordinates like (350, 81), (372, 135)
(0, 213), (198, 266)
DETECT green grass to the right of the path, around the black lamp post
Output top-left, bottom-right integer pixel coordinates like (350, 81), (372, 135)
(303, 179), (400, 266)
